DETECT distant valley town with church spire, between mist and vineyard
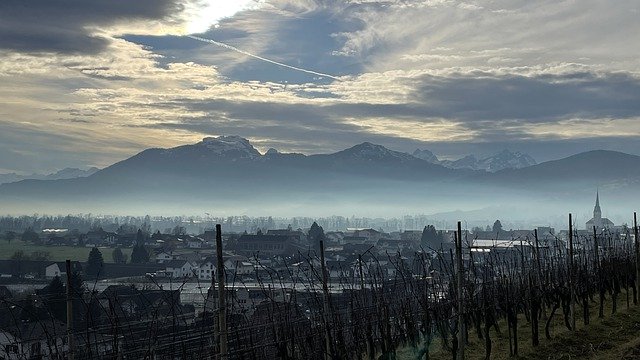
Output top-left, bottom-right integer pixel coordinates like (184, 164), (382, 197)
(0, 194), (630, 283)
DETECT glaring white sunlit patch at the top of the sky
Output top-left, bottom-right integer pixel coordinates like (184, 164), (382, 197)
(187, 0), (262, 34)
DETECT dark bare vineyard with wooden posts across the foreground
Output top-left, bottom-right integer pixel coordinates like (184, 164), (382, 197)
(0, 214), (640, 359)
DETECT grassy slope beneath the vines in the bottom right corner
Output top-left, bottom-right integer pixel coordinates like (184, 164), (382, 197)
(397, 291), (640, 360)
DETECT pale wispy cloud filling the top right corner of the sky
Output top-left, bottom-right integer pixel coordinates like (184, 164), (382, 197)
(337, 0), (640, 71)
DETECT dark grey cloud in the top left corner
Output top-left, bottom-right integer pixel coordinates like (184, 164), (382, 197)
(0, 0), (183, 53)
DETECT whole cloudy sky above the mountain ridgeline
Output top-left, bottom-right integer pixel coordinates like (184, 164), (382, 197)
(0, 0), (640, 173)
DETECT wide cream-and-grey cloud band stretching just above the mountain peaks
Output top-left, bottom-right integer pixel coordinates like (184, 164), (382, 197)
(62, 58), (640, 152)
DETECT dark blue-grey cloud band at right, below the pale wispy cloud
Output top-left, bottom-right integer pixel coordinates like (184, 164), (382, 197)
(414, 72), (640, 123)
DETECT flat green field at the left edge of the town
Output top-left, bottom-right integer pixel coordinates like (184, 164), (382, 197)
(0, 240), (131, 263)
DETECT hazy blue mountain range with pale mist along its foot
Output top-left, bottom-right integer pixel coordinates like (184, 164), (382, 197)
(0, 136), (640, 216)
